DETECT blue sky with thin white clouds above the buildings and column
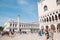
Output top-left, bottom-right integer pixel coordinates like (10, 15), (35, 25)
(0, 0), (38, 25)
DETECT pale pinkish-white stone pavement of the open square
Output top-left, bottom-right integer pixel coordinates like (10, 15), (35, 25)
(0, 33), (60, 40)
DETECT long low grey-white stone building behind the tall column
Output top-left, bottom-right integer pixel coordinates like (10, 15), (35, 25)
(4, 20), (39, 32)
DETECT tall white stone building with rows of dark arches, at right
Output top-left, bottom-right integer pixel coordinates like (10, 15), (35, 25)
(38, 0), (60, 32)
